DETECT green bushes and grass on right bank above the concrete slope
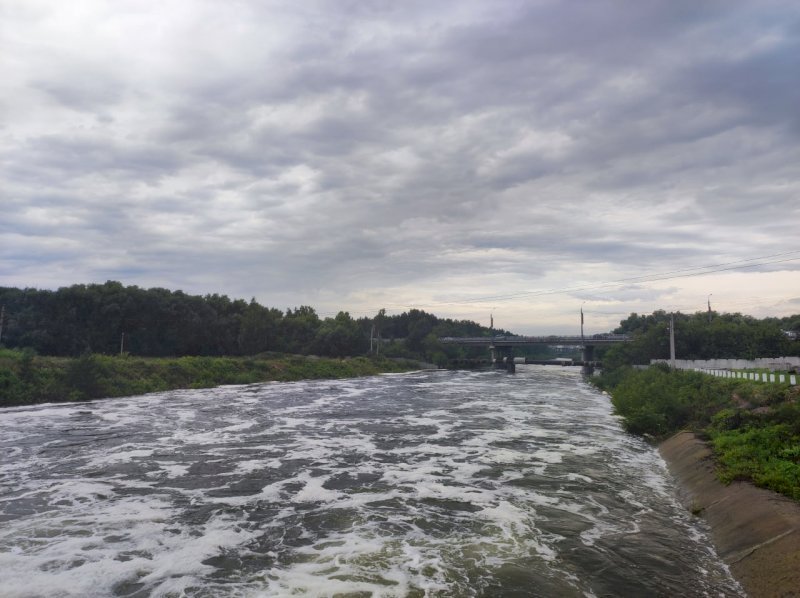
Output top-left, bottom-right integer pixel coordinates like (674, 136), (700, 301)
(595, 366), (800, 500)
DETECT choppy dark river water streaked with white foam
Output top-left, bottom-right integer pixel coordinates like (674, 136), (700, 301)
(0, 366), (743, 598)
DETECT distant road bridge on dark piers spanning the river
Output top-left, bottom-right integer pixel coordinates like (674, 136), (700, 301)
(439, 334), (630, 372)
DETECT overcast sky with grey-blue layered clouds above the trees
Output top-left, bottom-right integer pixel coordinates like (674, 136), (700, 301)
(0, 0), (800, 334)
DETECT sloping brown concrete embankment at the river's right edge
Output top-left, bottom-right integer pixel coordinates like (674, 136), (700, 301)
(659, 432), (800, 598)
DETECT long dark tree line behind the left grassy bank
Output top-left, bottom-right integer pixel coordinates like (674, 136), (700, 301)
(0, 281), (506, 360)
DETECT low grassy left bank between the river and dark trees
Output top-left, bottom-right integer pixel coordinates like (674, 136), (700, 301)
(0, 349), (416, 407)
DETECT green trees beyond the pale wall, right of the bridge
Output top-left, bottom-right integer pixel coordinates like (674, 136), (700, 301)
(602, 310), (800, 368)
